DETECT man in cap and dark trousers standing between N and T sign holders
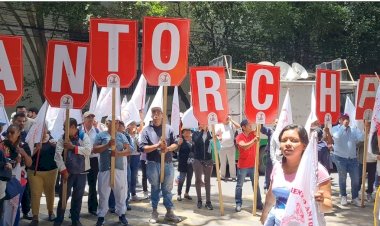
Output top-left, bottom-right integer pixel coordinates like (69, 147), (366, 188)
(79, 111), (99, 216)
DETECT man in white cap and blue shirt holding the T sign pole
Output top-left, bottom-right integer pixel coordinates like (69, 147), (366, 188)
(93, 116), (132, 226)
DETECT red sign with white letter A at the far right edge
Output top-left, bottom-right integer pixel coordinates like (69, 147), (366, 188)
(355, 75), (379, 120)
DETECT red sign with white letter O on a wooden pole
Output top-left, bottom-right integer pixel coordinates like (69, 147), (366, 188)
(142, 17), (190, 86)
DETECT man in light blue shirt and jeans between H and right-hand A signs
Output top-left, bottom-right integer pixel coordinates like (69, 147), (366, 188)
(332, 114), (364, 206)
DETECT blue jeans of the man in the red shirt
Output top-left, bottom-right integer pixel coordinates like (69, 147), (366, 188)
(235, 168), (262, 206)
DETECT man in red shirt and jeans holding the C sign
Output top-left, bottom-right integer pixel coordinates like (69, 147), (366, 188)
(235, 119), (263, 212)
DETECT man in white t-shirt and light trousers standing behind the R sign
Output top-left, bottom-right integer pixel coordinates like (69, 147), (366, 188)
(216, 116), (240, 181)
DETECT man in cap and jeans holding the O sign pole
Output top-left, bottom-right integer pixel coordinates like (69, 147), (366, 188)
(140, 107), (181, 223)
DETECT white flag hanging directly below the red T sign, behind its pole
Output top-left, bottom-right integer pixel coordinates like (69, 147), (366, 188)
(94, 87), (121, 122)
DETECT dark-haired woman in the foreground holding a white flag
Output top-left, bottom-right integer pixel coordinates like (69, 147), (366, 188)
(260, 124), (332, 226)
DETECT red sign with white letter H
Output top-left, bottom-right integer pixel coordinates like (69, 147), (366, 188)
(316, 69), (340, 124)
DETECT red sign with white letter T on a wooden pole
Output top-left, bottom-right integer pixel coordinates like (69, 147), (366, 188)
(90, 19), (137, 88)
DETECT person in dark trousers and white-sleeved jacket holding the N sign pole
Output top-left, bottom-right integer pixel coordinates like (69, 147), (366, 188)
(54, 118), (92, 226)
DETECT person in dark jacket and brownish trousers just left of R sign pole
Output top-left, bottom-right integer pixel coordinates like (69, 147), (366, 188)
(192, 125), (213, 210)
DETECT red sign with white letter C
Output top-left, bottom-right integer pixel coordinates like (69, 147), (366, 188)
(245, 63), (280, 124)
